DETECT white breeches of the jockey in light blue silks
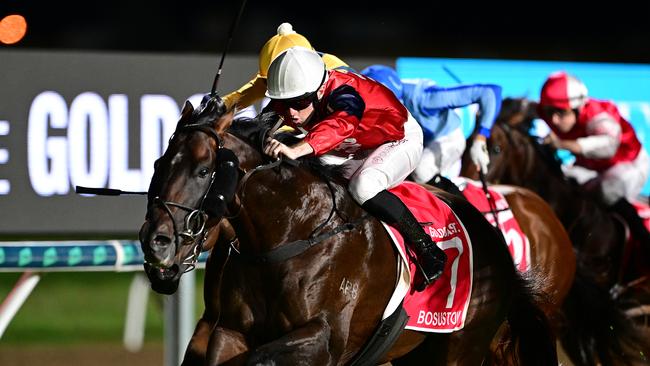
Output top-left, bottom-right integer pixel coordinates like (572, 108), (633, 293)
(413, 127), (466, 183)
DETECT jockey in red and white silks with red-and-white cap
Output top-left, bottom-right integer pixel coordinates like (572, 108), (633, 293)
(538, 72), (650, 243)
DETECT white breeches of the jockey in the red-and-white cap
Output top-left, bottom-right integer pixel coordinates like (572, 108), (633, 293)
(563, 149), (650, 205)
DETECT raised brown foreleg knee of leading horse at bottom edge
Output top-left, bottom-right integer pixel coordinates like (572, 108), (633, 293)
(207, 327), (248, 366)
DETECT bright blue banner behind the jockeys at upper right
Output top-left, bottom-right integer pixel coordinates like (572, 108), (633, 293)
(396, 57), (650, 196)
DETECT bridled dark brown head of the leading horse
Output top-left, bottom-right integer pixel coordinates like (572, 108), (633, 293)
(139, 97), (239, 294)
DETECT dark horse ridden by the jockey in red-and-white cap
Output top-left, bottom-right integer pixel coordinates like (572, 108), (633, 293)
(463, 98), (650, 365)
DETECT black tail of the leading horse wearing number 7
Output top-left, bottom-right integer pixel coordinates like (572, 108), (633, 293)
(501, 267), (557, 366)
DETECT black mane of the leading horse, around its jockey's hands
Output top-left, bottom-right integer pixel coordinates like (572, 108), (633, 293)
(228, 111), (346, 185)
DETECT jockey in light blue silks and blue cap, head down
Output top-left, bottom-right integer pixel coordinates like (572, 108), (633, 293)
(361, 65), (501, 184)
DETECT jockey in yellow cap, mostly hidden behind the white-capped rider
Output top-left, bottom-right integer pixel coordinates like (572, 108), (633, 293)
(223, 23), (350, 110)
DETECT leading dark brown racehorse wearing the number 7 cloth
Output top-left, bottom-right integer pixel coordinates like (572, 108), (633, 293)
(140, 97), (557, 365)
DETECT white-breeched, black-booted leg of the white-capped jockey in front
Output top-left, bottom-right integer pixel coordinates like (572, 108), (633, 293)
(349, 117), (447, 291)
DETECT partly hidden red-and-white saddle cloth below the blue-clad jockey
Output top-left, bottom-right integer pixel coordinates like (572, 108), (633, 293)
(454, 178), (531, 273)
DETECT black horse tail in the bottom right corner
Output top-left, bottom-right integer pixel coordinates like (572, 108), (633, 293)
(561, 264), (650, 365)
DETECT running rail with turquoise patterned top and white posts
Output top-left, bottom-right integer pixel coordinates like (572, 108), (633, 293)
(0, 240), (207, 366)
